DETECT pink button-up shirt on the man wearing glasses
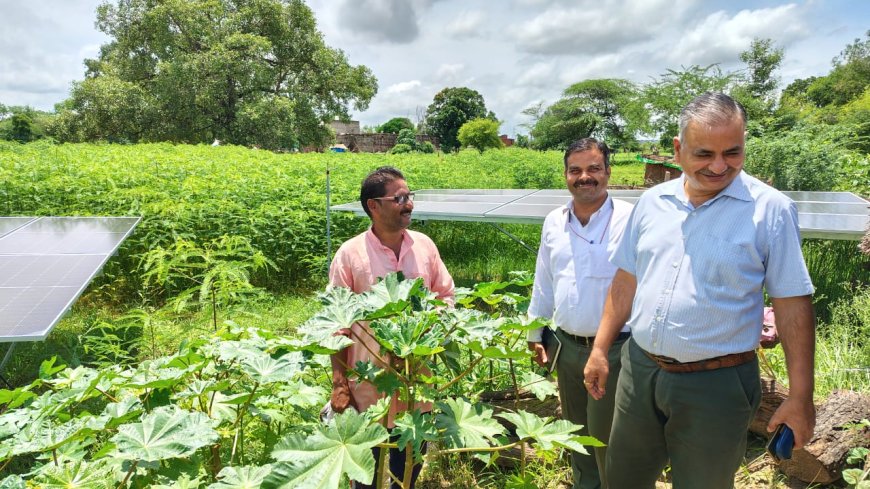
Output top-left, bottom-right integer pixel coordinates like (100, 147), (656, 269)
(329, 228), (453, 427)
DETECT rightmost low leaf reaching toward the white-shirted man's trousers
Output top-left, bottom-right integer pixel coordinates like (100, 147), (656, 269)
(498, 410), (604, 454)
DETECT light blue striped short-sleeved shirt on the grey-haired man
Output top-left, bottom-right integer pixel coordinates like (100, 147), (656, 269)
(610, 172), (813, 362)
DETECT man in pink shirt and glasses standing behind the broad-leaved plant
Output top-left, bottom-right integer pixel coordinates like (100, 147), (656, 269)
(329, 166), (453, 489)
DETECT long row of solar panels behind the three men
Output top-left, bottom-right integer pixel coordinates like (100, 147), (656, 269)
(331, 189), (870, 240)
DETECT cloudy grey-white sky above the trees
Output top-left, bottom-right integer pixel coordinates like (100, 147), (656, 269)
(0, 0), (870, 135)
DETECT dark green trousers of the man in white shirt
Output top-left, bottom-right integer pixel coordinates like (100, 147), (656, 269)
(556, 330), (626, 489)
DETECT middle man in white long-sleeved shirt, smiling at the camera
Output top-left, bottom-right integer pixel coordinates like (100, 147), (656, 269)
(528, 138), (632, 489)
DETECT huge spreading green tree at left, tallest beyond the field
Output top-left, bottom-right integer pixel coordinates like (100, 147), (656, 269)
(56, 0), (377, 148)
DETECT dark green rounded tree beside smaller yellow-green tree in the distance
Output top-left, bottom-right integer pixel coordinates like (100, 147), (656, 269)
(425, 87), (495, 152)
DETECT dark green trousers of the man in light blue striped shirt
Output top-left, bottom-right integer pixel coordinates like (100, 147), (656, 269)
(607, 340), (761, 489)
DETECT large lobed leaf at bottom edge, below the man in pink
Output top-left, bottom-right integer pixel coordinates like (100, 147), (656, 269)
(263, 409), (389, 489)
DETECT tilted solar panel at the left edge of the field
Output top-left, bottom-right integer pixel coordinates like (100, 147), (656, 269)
(0, 217), (139, 342)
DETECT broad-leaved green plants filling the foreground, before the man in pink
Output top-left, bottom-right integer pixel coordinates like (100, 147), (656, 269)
(0, 275), (597, 488)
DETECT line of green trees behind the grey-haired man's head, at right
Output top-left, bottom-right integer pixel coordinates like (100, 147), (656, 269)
(524, 31), (870, 154)
